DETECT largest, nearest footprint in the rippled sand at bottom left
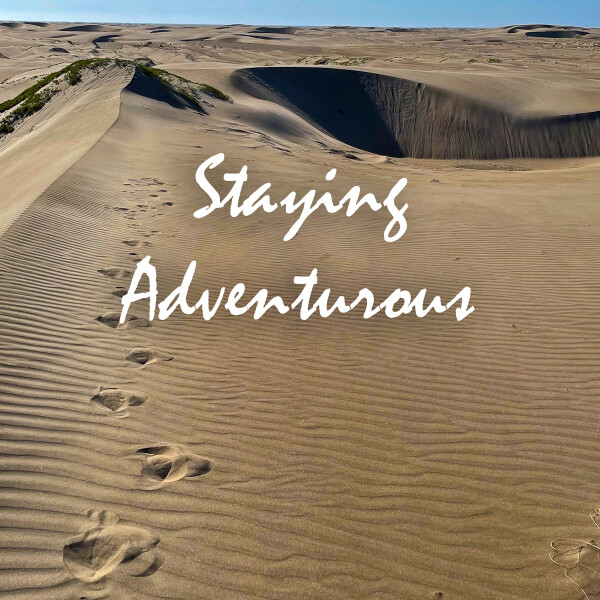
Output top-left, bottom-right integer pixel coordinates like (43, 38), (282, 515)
(63, 511), (164, 583)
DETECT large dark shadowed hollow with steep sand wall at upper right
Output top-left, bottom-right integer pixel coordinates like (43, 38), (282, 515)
(232, 67), (600, 159)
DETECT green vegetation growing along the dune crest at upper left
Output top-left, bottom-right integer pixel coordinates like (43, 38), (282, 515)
(0, 58), (231, 135)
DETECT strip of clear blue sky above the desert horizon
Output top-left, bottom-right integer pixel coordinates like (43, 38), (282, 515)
(0, 0), (600, 27)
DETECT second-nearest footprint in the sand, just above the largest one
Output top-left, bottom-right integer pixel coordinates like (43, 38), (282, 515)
(137, 444), (212, 489)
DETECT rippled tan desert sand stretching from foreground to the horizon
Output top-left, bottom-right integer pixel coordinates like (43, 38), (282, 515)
(0, 23), (600, 600)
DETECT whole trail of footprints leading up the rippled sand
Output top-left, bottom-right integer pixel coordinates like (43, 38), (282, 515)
(63, 177), (212, 598)
